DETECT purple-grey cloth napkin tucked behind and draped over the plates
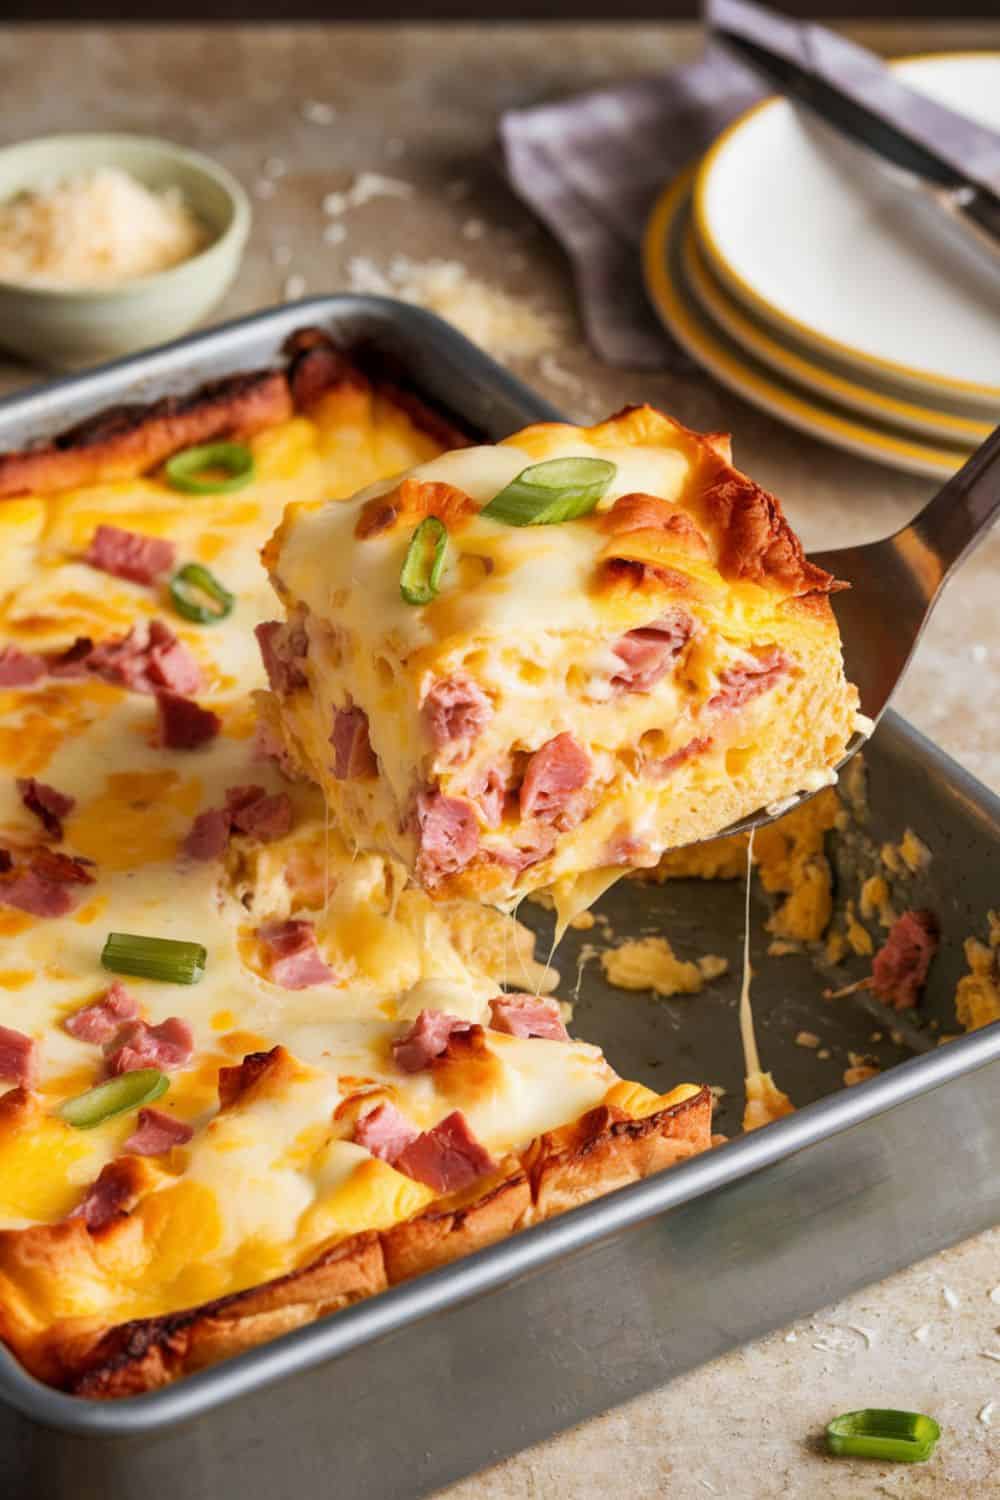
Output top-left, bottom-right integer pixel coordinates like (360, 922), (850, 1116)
(499, 0), (1000, 369)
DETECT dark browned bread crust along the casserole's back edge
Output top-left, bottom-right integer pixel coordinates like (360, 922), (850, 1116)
(0, 329), (469, 500)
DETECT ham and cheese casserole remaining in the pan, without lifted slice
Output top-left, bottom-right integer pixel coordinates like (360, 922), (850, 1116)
(0, 332), (711, 1397)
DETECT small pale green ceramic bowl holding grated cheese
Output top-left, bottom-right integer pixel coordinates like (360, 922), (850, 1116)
(0, 134), (250, 369)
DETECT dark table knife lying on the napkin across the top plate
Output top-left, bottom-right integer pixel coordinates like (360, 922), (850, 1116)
(709, 22), (1000, 263)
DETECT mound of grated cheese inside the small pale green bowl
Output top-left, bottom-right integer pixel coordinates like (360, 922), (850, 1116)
(0, 167), (208, 291)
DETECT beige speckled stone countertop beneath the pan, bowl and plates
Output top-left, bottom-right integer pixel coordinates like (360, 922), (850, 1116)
(0, 24), (1000, 1500)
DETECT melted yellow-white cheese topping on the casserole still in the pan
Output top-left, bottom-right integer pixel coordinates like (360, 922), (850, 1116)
(0, 392), (689, 1326)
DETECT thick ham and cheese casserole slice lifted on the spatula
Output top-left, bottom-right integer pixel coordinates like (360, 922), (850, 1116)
(259, 407), (858, 903)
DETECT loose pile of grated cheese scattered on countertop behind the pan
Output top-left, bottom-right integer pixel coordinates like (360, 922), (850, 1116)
(348, 255), (559, 359)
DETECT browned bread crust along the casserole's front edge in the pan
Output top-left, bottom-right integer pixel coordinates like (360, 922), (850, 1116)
(19, 1089), (712, 1400)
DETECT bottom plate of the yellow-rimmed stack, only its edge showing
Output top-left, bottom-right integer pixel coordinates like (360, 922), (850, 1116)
(643, 168), (970, 479)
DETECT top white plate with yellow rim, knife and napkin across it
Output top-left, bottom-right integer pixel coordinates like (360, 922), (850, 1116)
(694, 53), (1000, 414)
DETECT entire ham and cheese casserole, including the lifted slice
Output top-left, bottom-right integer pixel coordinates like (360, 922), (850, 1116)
(0, 330), (716, 1397)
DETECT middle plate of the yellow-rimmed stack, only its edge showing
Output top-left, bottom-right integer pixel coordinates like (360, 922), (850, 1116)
(681, 216), (994, 447)
